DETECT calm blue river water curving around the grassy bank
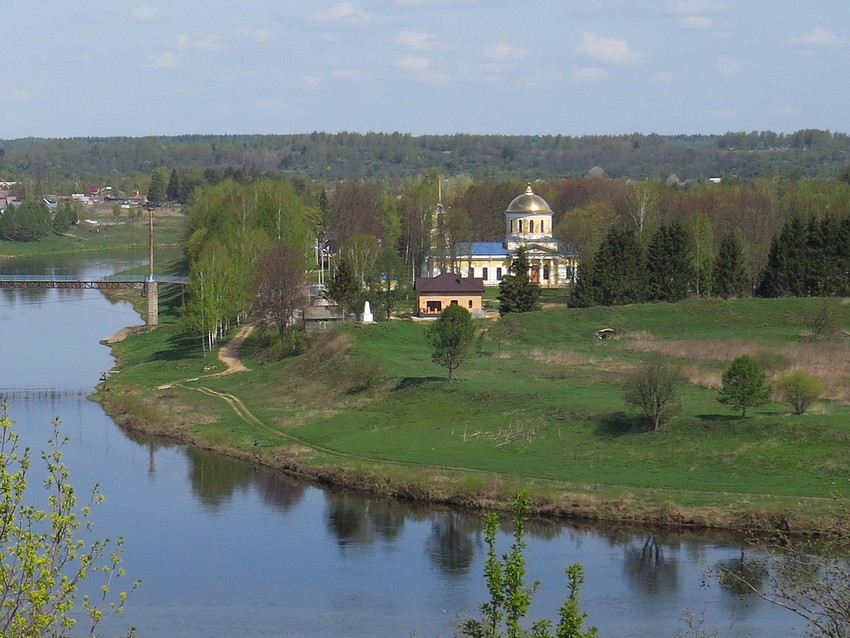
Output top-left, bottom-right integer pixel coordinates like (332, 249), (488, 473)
(0, 252), (805, 638)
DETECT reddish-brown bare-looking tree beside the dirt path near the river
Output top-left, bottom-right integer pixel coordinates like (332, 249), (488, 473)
(256, 244), (307, 334)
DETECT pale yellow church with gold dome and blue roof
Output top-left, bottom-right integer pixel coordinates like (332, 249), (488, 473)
(425, 184), (578, 288)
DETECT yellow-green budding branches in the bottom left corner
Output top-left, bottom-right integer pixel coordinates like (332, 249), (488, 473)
(0, 404), (139, 638)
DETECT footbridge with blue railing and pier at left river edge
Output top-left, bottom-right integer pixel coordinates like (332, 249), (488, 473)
(0, 274), (189, 326)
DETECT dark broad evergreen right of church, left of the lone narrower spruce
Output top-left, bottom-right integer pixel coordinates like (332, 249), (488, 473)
(646, 222), (693, 301)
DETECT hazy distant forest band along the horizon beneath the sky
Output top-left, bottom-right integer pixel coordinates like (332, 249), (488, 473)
(0, 129), (850, 190)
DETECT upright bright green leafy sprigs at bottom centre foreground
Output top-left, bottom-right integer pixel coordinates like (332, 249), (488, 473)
(460, 494), (597, 638)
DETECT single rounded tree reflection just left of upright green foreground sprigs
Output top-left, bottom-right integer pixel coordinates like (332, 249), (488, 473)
(425, 511), (481, 576)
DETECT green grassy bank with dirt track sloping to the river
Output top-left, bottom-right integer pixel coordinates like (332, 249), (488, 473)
(94, 292), (850, 529)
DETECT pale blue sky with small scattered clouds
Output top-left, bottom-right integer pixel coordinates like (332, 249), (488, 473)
(0, 0), (850, 139)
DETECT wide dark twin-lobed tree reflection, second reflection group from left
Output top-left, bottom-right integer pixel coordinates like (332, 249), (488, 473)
(325, 492), (405, 546)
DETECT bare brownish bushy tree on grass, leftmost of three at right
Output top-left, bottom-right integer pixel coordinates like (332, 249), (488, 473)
(623, 357), (682, 430)
